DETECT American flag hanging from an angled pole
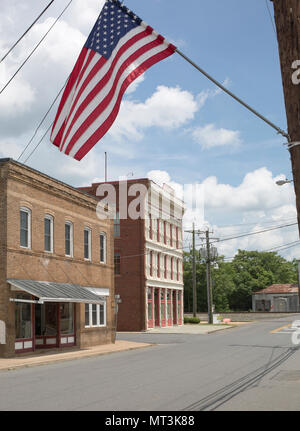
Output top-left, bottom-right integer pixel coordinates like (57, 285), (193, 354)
(50, 0), (176, 160)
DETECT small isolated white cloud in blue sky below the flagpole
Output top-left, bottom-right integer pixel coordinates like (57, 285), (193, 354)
(192, 124), (242, 149)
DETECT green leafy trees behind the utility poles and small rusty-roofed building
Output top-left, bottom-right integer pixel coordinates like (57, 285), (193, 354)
(183, 250), (298, 313)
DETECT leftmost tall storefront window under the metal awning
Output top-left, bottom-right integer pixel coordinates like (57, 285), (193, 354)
(15, 294), (32, 339)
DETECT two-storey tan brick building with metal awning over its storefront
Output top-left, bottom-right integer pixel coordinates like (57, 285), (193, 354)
(0, 159), (115, 357)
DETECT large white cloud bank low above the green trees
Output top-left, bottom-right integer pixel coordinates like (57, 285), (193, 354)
(148, 168), (300, 259)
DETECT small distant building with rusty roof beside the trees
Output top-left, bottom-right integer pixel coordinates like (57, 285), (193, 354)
(252, 284), (299, 313)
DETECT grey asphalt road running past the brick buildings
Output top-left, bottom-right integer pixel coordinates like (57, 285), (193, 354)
(0, 316), (300, 411)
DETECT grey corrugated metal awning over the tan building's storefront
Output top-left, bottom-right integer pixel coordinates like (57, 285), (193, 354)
(7, 278), (109, 304)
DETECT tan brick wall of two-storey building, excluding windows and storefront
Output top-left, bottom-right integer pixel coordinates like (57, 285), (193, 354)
(0, 162), (115, 356)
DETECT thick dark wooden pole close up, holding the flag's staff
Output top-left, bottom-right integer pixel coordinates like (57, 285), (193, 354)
(271, 0), (300, 233)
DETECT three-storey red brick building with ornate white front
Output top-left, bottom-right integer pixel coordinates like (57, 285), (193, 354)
(78, 178), (184, 331)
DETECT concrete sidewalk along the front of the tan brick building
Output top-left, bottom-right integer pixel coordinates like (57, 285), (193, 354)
(0, 340), (154, 371)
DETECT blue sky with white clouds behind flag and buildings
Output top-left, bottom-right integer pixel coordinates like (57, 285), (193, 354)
(0, 0), (300, 259)
